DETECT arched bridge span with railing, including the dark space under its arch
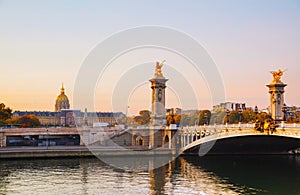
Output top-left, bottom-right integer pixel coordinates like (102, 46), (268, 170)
(179, 123), (300, 154)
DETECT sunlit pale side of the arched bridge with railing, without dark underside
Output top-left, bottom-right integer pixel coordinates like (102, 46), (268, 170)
(179, 123), (300, 153)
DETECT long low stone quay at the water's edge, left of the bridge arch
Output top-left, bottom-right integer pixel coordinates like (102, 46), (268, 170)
(0, 146), (174, 159)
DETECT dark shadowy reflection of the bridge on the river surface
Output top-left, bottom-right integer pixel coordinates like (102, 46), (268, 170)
(185, 155), (300, 194)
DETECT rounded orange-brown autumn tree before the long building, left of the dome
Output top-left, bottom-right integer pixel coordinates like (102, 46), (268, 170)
(10, 114), (41, 128)
